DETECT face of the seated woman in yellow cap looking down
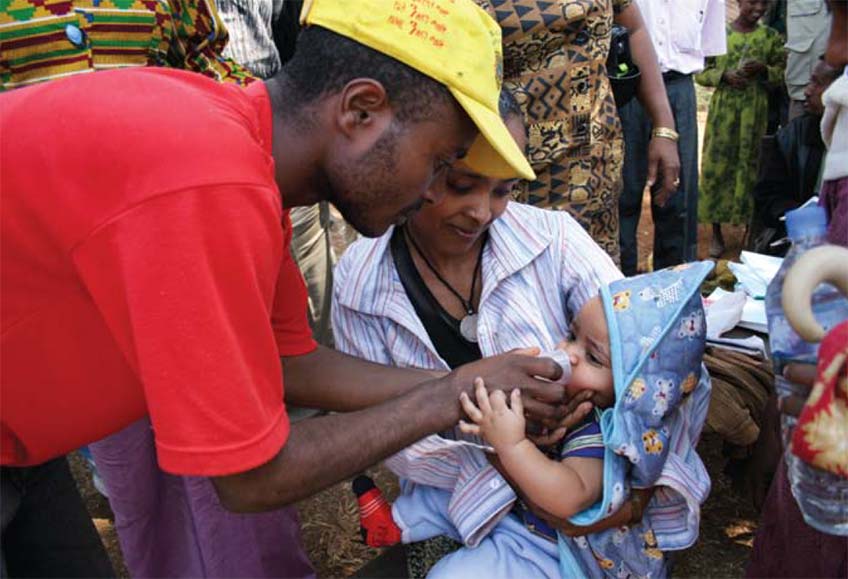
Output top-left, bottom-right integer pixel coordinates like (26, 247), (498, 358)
(409, 115), (527, 256)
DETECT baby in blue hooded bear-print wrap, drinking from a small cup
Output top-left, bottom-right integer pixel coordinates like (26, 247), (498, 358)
(454, 262), (712, 577)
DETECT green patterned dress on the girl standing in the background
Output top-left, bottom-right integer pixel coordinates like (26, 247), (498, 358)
(695, 24), (785, 225)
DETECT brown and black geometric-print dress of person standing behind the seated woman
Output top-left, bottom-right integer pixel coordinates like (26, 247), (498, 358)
(476, 0), (632, 262)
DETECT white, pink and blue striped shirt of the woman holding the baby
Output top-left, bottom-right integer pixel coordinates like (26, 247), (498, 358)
(333, 203), (709, 548)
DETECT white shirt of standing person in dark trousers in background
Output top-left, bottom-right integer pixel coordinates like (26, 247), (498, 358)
(636, 0), (727, 74)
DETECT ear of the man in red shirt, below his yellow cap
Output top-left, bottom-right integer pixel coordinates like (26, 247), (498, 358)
(336, 78), (393, 138)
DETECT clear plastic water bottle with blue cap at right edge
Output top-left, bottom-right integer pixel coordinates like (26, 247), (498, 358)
(766, 206), (848, 535)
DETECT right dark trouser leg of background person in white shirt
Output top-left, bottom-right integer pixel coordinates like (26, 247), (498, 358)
(651, 77), (698, 269)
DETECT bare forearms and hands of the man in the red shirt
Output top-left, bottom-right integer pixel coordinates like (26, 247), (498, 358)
(213, 349), (564, 512)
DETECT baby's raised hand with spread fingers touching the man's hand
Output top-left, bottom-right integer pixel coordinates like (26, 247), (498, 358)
(459, 378), (524, 451)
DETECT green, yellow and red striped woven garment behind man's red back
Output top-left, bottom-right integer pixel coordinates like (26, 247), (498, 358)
(0, 0), (252, 90)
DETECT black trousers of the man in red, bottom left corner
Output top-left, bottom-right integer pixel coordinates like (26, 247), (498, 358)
(2, 457), (115, 577)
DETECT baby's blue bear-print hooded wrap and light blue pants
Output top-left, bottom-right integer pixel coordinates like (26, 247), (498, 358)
(393, 262), (713, 579)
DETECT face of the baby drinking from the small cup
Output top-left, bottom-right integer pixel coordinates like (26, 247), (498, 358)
(557, 297), (615, 408)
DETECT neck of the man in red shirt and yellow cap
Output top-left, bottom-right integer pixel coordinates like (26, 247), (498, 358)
(265, 75), (327, 209)
